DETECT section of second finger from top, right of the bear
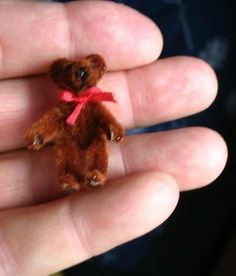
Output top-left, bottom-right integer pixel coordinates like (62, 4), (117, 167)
(101, 57), (217, 128)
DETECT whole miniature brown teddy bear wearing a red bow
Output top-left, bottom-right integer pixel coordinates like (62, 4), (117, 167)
(25, 54), (124, 190)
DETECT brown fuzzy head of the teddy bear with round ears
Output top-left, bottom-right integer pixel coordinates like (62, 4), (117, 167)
(49, 54), (106, 94)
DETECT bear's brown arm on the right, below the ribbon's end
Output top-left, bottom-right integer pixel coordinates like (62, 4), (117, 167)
(96, 103), (124, 142)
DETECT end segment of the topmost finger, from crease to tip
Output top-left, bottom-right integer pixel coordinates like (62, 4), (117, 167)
(67, 1), (163, 70)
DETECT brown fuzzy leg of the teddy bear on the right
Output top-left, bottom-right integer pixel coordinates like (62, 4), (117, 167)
(85, 139), (108, 188)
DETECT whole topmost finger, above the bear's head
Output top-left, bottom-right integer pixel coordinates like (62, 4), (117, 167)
(0, 1), (162, 78)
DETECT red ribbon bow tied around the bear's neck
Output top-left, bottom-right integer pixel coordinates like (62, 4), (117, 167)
(59, 86), (116, 125)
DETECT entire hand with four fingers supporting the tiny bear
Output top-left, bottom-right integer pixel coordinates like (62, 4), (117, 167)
(0, 1), (227, 275)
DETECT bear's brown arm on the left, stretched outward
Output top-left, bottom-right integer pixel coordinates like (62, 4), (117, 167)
(25, 107), (61, 150)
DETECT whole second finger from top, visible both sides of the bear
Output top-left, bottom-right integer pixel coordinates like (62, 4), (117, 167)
(0, 57), (217, 151)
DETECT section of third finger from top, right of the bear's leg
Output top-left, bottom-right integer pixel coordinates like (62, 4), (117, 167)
(110, 127), (227, 188)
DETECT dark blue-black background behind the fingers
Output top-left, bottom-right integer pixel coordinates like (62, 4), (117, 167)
(57, 0), (236, 276)
